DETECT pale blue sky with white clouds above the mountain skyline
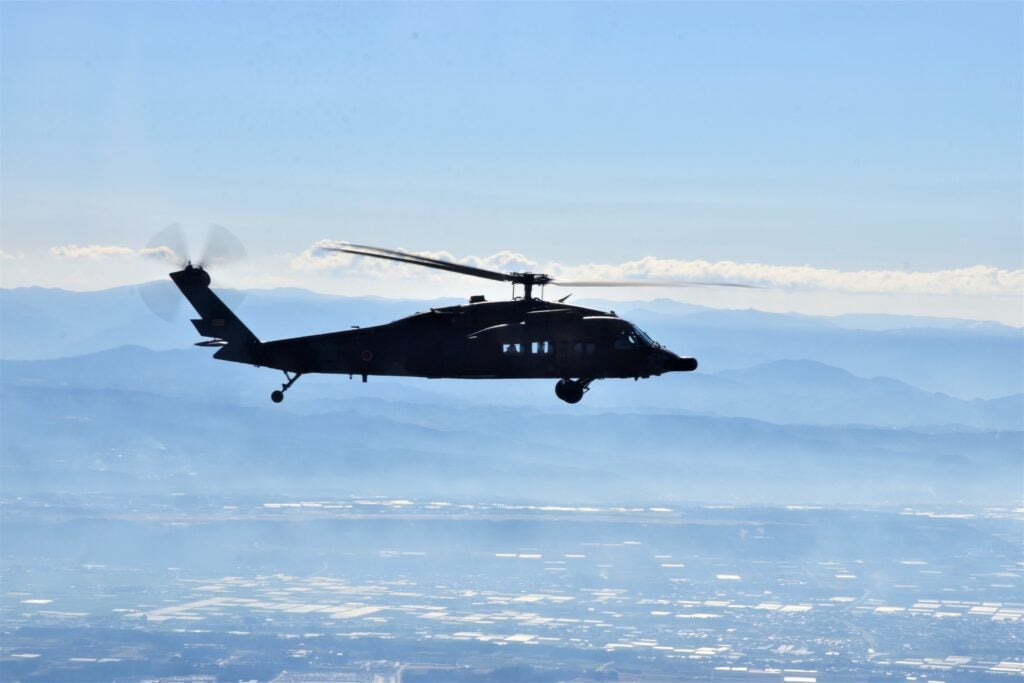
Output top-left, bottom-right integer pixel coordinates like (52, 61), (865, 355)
(0, 2), (1024, 325)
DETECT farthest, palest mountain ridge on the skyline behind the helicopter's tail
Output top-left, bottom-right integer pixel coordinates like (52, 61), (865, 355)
(0, 283), (1024, 398)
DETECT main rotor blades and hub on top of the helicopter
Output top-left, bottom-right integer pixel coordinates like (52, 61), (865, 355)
(318, 242), (757, 300)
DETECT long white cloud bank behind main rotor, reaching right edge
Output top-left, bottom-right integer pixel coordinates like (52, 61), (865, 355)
(291, 240), (1024, 296)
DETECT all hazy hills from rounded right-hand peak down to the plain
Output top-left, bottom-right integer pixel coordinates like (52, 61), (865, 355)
(0, 333), (1024, 505)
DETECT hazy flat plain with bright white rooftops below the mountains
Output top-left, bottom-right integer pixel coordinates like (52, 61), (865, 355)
(0, 496), (1024, 683)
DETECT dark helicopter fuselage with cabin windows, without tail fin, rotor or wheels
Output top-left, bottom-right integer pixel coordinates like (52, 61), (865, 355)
(241, 299), (696, 379)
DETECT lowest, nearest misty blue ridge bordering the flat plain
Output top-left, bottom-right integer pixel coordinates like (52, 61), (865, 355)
(2, 384), (1024, 503)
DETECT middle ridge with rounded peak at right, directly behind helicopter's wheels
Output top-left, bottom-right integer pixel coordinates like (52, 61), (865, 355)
(0, 346), (1024, 430)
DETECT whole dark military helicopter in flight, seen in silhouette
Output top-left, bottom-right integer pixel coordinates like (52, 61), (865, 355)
(170, 243), (751, 403)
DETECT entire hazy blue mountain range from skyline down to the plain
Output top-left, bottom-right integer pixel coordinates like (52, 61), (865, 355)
(0, 288), (1024, 504)
